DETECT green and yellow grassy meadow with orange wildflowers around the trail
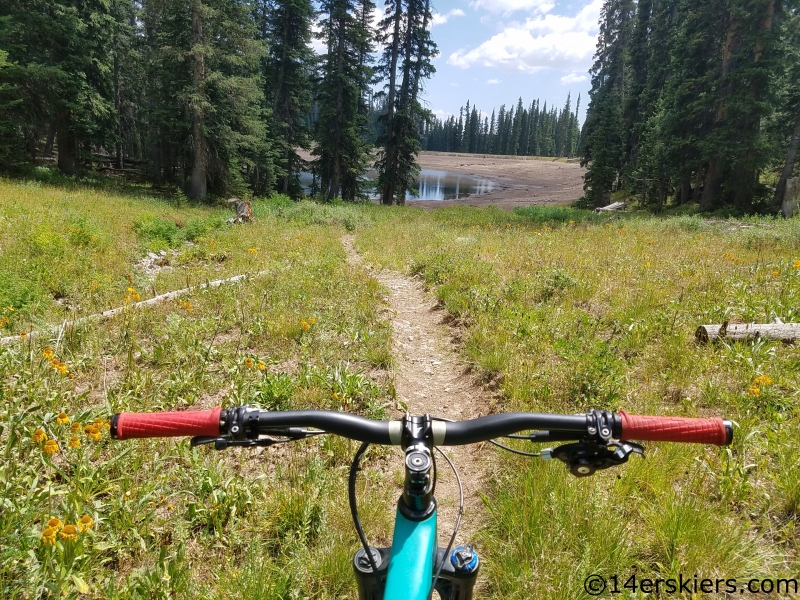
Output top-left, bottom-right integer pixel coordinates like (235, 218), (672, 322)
(0, 176), (800, 600)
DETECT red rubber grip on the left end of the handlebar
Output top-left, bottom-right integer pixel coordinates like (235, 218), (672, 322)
(112, 406), (222, 440)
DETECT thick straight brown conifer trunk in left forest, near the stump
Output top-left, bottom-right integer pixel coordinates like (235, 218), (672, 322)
(188, 0), (208, 200)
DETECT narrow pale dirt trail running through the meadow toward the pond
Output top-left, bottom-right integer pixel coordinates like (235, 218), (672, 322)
(342, 236), (492, 550)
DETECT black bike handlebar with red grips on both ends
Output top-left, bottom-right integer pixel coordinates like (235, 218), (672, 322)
(111, 406), (733, 446)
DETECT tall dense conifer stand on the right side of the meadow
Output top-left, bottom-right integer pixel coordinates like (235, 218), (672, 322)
(582, 0), (800, 212)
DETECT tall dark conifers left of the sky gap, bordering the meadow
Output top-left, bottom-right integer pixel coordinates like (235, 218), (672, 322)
(0, 0), (436, 204)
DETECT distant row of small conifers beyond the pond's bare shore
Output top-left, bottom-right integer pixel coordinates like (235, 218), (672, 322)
(422, 94), (581, 157)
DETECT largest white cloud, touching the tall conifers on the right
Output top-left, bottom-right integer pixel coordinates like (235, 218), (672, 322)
(447, 0), (603, 73)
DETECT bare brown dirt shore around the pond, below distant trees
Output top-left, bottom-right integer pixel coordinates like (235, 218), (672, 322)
(416, 152), (585, 209)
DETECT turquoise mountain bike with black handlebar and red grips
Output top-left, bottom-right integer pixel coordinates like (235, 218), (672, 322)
(111, 406), (733, 600)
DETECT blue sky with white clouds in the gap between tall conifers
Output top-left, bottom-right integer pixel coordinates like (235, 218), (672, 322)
(418, 0), (602, 121)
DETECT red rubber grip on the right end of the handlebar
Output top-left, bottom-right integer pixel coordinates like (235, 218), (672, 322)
(619, 410), (730, 446)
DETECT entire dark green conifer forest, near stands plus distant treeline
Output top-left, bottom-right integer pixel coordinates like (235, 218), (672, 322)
(0, 0), (800, 212)
